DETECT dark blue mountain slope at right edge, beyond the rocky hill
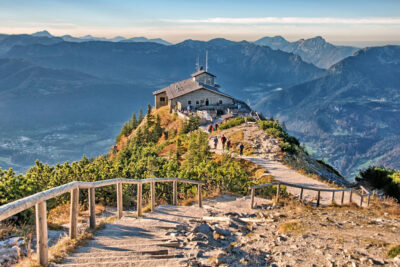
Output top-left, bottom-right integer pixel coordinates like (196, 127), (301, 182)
(256, 46), (400, 180)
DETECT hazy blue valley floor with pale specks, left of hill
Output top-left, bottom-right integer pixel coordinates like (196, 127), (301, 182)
(0, 123), (121, 173)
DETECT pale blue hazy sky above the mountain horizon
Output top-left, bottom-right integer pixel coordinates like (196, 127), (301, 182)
(0, 0), (400, 46)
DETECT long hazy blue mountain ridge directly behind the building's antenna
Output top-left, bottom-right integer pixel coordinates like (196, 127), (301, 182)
(4, 37), (324, 102)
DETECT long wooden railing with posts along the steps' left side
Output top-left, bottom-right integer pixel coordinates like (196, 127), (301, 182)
(0, 178), (205, 266)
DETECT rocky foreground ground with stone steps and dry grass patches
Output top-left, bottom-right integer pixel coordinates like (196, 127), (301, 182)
(50, 195), (400, 266)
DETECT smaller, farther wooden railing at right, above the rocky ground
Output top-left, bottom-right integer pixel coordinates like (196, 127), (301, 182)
(250, 182), (372, 209)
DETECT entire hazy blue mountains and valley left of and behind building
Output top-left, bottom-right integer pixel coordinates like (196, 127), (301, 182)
(0, 35), (324, 170)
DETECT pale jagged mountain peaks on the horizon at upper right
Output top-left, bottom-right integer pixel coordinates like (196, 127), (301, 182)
(254, 36), (359, 69)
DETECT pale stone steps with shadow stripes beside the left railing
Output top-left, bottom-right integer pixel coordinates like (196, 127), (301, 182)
(52, 205), (206, 267)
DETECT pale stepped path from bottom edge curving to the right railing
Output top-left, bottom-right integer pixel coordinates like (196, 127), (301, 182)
(52, 195), (269, 267)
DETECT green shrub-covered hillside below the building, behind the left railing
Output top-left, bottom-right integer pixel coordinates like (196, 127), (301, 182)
(0, 106), (265, 220)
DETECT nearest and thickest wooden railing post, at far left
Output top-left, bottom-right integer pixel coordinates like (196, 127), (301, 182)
(35, 201), (49, 266)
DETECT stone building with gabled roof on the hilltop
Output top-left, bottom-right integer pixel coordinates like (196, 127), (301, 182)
(153, 67), (241, 112)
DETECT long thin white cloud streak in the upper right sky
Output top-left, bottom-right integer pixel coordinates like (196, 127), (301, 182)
(162, 17), (400, 25)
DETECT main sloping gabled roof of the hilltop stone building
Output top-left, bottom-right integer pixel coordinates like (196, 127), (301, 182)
(153, 78), (234, 99)
